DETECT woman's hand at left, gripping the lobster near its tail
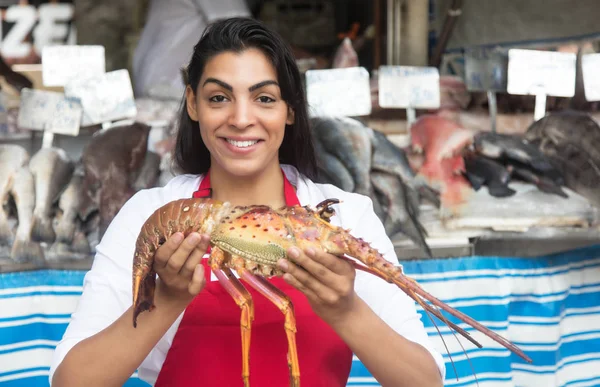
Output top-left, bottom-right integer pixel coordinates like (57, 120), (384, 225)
(154, 232), (209, 305)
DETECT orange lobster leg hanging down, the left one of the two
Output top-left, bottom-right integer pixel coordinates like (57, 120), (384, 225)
(210, 247), (254, 387)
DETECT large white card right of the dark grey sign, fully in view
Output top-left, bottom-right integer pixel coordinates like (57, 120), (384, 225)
(508, 49), (577, 97)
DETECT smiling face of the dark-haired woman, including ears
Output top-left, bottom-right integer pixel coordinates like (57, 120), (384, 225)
(186, 49), (294, 177)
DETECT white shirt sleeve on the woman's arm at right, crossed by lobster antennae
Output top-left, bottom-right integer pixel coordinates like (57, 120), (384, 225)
(344, 196), (446, 378)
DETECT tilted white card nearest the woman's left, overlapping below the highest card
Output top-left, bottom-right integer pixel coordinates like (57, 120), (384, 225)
(65, 70), (137, 126)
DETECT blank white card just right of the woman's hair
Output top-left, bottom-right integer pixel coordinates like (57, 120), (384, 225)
(306, 67), (371, 117)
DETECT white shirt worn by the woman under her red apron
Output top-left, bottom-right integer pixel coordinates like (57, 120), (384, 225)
(50, 165), (445, 384)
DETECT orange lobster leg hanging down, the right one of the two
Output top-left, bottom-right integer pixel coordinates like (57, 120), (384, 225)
(236, 267), (300, 387)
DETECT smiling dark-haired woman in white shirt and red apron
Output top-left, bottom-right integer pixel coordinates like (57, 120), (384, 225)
(50, 19), (445, 387)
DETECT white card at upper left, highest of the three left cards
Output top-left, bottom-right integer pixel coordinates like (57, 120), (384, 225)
(42, 45), (106, 87)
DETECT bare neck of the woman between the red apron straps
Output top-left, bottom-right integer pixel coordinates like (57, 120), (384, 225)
(210, 164), (285, 208)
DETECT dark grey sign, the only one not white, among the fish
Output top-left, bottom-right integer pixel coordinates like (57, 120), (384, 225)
(465, 49), (508, 92)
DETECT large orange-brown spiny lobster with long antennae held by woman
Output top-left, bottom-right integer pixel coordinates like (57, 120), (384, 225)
(133, 198), (531, 387)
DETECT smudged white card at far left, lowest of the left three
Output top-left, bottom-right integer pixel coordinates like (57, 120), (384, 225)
(17, 88), (83, 136)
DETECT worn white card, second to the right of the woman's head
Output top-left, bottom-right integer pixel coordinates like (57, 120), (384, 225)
(379, 66), (440, 109)
